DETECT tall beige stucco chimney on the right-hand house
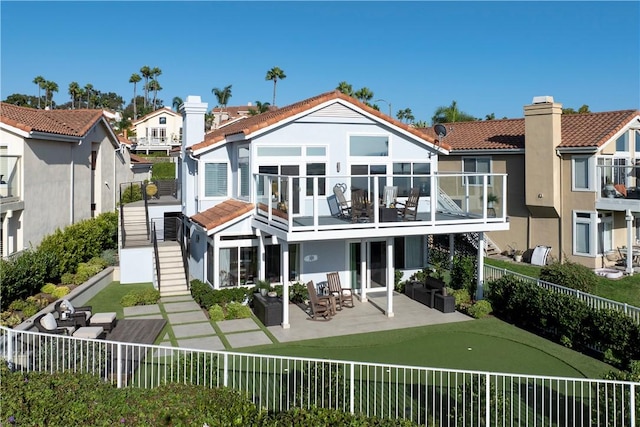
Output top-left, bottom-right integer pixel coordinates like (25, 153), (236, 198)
(524, 96), (562, 218)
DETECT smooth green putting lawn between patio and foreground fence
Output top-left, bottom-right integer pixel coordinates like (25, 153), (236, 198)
(242, 318), (614, 378)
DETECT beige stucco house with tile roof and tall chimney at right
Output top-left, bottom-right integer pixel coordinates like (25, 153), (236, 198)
(427, 96), (640, 272)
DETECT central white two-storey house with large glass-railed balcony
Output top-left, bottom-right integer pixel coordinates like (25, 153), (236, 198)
(121, 91), (509, 327)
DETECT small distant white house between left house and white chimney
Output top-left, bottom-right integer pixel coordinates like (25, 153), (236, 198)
(129, 108), (182, 154)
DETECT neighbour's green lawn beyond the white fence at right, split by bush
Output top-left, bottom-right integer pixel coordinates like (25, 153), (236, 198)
(485, 258), (640, 307)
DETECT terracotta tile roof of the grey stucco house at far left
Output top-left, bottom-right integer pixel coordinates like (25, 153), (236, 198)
(0, 102), (104, 137)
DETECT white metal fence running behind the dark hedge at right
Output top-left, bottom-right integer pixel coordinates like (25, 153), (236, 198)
(484, 264), (640, 323)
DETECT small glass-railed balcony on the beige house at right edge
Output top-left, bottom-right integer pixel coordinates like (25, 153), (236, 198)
(596, 159), (640, 212)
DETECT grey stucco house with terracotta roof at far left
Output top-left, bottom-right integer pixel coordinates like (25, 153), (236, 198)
(0, 103), (132, 257)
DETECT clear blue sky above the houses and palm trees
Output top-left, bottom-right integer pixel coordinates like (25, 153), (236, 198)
(0, 0), (640, 122)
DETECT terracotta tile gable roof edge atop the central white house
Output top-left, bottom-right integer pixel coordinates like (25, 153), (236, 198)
(190, 90), (449, 155)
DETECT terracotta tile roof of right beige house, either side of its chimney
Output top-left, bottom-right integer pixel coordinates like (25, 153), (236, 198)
(424, 110), (640, 152)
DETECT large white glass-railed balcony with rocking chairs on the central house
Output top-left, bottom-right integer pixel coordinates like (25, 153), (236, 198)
(253, 173), (509, 241)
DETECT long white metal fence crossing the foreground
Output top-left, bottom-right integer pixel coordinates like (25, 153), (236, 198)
(0, 328), (640, 427)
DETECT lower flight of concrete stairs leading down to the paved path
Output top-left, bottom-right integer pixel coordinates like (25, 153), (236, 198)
(153, 241), (191, 297)
